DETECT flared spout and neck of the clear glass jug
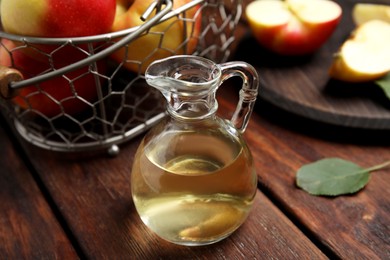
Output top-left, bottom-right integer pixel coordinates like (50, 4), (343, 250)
(145, 55), (221, 119)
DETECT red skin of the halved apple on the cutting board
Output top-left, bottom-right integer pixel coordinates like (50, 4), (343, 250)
(247, 0), (342, 55)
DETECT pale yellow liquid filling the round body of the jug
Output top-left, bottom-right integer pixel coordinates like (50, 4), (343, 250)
(132, 133), (257, 245)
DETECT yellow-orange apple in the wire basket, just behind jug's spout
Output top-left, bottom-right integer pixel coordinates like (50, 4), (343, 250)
(112, 0), (202, 73)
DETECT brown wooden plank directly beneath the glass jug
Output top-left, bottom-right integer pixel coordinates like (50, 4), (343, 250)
(19, 132), (326, 259)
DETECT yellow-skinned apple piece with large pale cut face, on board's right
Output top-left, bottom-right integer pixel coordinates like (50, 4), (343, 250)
(329, 20), (390, 82)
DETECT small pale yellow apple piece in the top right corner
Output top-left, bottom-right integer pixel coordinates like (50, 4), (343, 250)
(352, 3), (390, 25)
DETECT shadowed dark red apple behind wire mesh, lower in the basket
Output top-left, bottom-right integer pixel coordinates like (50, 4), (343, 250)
(0, 39), (106, 118)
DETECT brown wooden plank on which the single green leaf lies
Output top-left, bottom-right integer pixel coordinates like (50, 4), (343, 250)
(246, 96), (390, 259)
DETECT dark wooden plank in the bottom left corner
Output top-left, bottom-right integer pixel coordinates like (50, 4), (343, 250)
(0, 120), (78, 259)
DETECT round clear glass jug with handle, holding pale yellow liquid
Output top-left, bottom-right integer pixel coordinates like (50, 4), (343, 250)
(131, 55), (258, 246)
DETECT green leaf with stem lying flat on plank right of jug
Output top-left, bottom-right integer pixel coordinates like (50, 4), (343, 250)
(296, 158), (390, 196)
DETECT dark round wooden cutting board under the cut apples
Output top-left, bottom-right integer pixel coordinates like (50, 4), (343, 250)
(233, 1), (390, 129)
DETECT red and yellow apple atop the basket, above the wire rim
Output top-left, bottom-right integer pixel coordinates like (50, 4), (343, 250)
(0, 0), (116, 37)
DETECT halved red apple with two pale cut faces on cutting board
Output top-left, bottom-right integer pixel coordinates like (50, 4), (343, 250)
(246, 0), (342, 55)
